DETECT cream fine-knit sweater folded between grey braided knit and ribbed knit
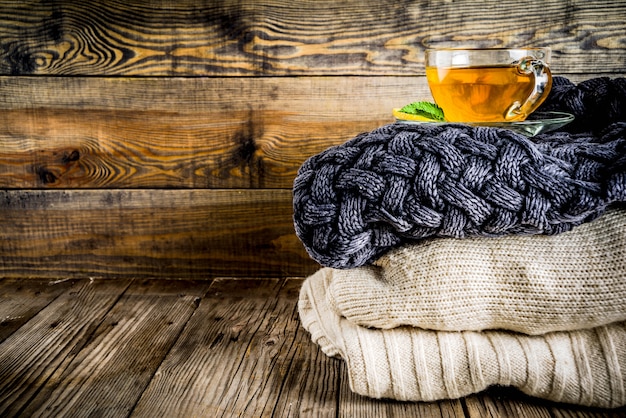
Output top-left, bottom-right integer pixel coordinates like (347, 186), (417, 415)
(326, 209), (626, 334)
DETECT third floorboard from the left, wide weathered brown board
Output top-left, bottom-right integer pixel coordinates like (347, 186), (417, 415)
(23, 280), (210, 417)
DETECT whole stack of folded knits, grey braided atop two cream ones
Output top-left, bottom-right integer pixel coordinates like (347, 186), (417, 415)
(294, 77), (626, 408)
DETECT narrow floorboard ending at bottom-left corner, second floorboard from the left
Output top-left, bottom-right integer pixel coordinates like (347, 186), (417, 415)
(0, 280), (129, 416)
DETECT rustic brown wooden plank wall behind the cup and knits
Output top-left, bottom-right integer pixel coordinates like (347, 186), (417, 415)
(0, 0), (626, 278)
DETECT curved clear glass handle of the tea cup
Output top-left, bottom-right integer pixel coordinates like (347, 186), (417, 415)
(505, 57), (552, 121)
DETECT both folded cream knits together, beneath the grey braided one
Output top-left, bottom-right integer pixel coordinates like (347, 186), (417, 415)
(298, 210), (626, 408)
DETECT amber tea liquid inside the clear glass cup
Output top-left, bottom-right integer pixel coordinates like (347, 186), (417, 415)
(426, 65), (540, 122)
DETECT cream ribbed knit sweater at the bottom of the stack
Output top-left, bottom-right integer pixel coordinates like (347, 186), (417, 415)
(298, 276), (626, 408)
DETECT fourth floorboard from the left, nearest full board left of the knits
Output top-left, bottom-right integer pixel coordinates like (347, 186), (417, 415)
(133, 279), (280, 417)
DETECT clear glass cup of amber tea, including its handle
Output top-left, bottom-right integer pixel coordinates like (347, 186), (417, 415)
(426, 48), (552, 122)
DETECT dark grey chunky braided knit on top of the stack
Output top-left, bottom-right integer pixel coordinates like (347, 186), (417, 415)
(293, 77), (626, 268)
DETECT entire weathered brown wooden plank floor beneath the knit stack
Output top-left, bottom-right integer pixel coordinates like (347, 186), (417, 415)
(0, 278), (626, 418)
